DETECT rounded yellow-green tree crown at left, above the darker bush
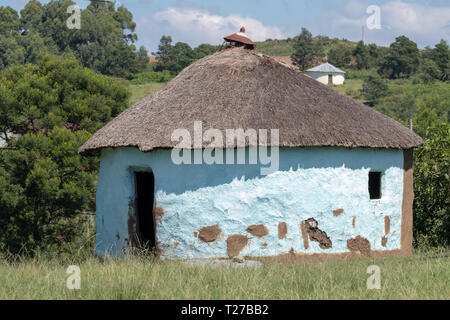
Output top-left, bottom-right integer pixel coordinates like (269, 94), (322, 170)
(0, 55), (129, 140)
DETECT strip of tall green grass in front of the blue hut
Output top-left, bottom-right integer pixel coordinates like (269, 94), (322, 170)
(0, 250), (450, 300)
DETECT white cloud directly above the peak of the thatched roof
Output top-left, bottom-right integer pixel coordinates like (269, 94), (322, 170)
(154, 8), (286, 44)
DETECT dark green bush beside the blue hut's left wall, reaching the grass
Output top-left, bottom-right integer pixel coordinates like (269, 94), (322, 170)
(0, 128), (98, 254)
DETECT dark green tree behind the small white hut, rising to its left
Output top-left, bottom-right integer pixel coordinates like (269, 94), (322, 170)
(292, 28), (323, 69)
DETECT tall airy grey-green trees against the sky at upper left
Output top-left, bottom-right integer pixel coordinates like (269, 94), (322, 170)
(0, 0), (147, 77)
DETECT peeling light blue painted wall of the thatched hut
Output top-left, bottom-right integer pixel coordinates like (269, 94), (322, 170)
(96, 147), (403, 259)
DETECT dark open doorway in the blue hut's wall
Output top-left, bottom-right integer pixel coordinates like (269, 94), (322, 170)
(134, 172), (156, 252)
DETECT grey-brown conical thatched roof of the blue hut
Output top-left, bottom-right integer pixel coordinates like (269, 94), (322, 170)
(79, 48), (423, 153)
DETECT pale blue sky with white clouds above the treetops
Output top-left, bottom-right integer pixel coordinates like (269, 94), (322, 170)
(0, 0), (450, 52)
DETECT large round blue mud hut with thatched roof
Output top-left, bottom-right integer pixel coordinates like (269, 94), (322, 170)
(79, 47), (423, 259)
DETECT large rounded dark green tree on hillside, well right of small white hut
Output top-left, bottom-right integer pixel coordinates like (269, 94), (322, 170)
(378, 36), (419, 79)
